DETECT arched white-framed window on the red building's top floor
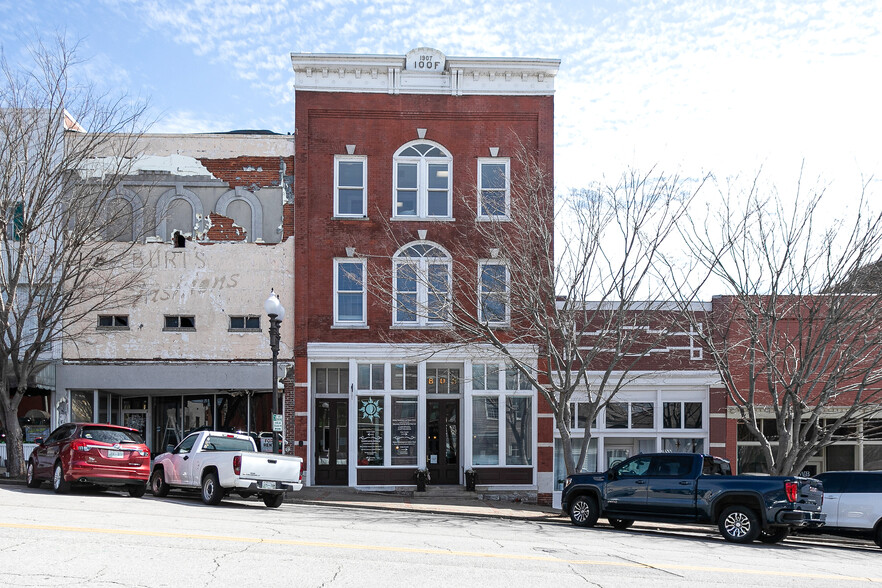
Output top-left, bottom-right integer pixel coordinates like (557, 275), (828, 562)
(392, 140), (453, 218)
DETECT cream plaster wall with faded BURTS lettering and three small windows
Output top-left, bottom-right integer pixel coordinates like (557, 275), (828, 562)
(63, 238), (294, 358)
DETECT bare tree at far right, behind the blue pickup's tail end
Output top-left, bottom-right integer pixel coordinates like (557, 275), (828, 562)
(682, 171), (882, 474)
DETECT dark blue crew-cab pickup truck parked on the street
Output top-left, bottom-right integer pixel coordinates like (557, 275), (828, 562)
(561, 453), (826, 543)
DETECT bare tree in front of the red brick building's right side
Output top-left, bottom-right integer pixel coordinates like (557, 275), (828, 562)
(361, 146), (702, 474)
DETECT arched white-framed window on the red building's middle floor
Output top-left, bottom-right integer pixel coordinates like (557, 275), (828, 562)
(392, 241), (450, 325)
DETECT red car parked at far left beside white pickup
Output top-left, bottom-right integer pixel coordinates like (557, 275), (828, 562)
(27, 423), (150, 498)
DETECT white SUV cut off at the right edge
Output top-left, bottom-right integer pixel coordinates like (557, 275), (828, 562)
(815, 471), (882, 547)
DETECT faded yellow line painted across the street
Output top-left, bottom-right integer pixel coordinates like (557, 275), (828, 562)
(0, 523), (882, 583)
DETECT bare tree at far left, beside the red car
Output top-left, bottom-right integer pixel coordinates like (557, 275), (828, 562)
(0, 37), (145, 476)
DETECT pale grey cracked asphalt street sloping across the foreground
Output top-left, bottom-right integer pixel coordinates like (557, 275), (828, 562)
(0, 486), (882, 588)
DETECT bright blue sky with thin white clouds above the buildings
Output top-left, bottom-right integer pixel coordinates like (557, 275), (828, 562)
(0, 0), (882, 189)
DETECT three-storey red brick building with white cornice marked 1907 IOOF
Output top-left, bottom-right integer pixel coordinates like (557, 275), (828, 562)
(288, 49), (559, 496)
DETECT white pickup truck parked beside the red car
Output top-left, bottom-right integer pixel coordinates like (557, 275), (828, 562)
(150, 431), (303, 508)
